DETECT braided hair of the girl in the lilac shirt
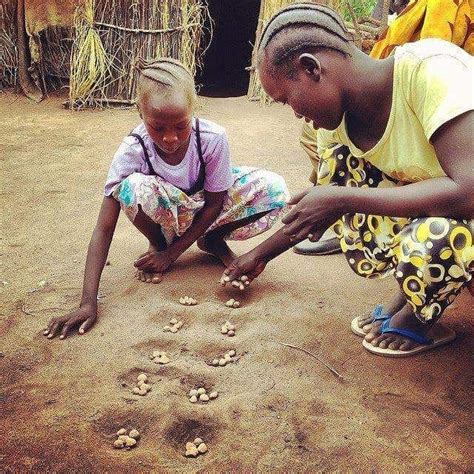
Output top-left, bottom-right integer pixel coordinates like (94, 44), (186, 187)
(137, 58), (197, 107)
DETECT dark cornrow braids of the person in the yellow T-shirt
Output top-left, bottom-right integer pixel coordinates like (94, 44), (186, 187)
(258, 3), (353, 76)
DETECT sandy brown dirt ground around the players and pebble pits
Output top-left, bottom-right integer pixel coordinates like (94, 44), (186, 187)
(0, 90), (474, 473)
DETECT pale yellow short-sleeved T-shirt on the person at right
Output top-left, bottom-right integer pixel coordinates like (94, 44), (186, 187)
(318, 39), (474, 183)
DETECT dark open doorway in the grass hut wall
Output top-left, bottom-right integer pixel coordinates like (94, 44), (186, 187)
(196, 0), (260, 97)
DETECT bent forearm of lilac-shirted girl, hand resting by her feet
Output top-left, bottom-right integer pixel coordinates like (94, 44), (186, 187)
(135, 191), (227, 273)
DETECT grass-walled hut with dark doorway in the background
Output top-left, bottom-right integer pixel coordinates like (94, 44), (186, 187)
(0, 0), (388, 108)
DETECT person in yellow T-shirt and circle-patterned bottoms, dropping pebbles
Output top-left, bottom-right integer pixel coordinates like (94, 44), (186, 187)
(224, 4), (474, 356)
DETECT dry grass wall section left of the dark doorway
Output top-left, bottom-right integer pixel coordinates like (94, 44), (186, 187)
(70, 0), (209, 106)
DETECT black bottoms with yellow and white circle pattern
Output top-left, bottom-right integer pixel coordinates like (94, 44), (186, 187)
(318, 145), (474, 323)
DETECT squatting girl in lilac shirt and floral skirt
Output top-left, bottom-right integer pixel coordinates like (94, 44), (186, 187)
(44, 58), (289, 339)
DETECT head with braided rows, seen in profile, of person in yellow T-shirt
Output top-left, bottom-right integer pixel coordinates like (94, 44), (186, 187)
(252, 3), (365, 130)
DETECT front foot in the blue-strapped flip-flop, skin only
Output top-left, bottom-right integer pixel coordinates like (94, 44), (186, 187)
(364, 303), (432, 351)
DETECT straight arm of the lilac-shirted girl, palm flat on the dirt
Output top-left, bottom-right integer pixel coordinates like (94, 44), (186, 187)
(44, 196), (120, 339)
